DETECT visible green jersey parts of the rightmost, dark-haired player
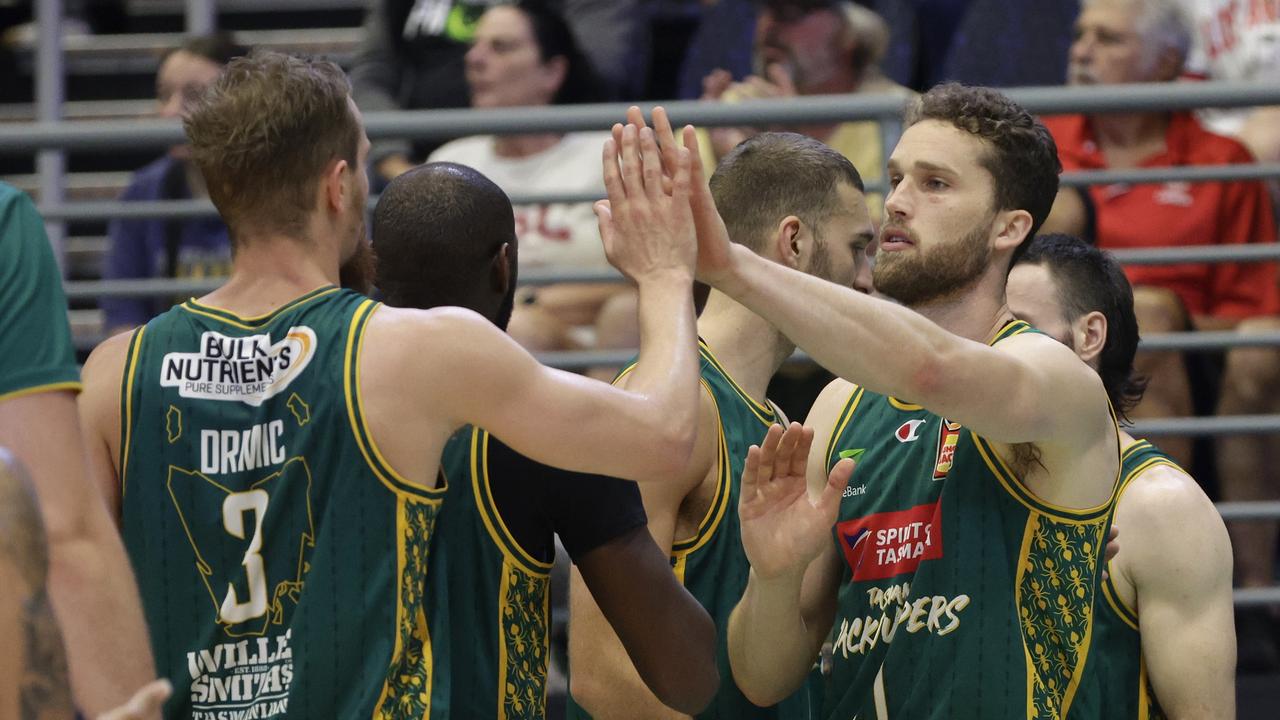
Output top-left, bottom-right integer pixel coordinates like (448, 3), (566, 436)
(1091, 439), (1178, 720)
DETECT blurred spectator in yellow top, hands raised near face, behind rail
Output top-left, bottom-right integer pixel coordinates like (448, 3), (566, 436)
(703, 0), (906, 215)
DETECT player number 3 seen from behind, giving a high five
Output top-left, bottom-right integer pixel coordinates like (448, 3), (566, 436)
(74, 53), (698, 719)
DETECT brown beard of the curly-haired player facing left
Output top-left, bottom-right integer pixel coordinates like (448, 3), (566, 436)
(872, 223), (991, 307)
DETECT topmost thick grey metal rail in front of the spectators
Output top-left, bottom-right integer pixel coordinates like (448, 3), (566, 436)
(0, 82), (1280, 152)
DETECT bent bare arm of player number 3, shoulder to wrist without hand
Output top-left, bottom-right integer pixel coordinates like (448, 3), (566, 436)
(376, 275), (698, 482)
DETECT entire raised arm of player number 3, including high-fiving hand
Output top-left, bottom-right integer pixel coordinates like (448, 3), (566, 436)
(378, 120), (698, 482)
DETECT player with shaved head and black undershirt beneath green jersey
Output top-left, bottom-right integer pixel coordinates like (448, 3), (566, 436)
(372, 163), (718, 719)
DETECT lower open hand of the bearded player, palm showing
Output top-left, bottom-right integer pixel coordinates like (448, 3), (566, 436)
(737, 423), (854, 579)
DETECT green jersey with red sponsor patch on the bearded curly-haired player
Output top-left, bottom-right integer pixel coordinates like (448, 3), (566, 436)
(823, 322), (1112, 720)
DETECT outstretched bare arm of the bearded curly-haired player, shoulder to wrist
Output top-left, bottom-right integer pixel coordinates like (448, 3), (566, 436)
(716, 240), (1111, 446)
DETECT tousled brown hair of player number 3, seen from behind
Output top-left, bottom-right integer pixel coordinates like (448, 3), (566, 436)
(183, 50), (364, 247)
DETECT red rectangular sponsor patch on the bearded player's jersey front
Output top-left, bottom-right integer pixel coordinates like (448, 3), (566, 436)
(836, 501), (942, 580)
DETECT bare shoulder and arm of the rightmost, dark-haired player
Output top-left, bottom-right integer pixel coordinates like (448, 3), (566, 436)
(1116, 466), (1235, 720)
